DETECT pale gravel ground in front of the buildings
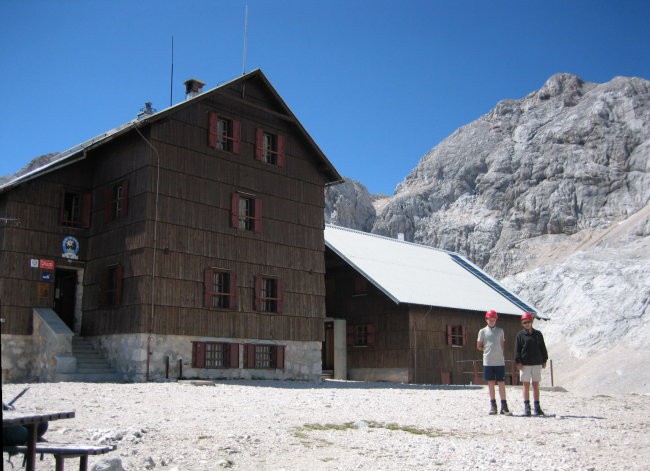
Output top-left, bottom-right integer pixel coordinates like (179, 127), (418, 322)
(2, 381), (650, 471)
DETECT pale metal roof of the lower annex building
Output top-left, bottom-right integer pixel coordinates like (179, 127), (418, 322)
(325, 224), (538, 315)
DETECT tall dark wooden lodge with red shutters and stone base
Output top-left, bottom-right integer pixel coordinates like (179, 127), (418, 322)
(0, 70), (342, 381)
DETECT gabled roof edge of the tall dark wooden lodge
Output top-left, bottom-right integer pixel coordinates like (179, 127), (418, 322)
(0, 69), (343, 193)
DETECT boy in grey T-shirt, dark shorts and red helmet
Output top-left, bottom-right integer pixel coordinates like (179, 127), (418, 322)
(476, 309), (512, 415)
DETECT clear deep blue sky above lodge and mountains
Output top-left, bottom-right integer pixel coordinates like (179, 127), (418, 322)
(0, 0), (650, 194)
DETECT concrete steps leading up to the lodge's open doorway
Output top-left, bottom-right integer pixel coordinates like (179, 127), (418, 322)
(56, 335), (122, 383)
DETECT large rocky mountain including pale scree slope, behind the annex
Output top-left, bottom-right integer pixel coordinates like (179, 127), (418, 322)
(326, 74), (650, 392)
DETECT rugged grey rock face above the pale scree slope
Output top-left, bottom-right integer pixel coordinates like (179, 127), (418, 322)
(372, 74), (650, 277)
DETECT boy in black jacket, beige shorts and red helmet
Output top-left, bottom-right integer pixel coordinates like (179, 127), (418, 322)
(515, 312), (548, 416)
